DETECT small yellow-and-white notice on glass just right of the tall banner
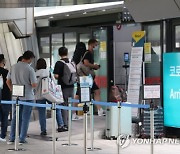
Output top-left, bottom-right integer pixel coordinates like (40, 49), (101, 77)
(144, 43), (151, 63)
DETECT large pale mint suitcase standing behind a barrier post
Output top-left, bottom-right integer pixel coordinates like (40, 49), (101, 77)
(106, 106), (132, 139)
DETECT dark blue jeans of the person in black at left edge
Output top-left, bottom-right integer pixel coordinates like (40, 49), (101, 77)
(0, 104), (11, 139)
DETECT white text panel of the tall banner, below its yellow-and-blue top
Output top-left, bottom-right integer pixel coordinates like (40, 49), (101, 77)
(127, 47), (143, 116)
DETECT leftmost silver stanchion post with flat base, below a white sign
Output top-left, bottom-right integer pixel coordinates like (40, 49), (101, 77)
(8, 97), (25, 151)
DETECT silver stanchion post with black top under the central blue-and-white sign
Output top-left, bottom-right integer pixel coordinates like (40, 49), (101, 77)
(83, 103), (88, 154)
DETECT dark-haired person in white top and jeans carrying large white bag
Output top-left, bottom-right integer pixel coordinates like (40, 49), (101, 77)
(35, 58), (67, 136)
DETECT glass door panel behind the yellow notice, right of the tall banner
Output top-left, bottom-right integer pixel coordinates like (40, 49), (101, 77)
(144, 23), (163, 106)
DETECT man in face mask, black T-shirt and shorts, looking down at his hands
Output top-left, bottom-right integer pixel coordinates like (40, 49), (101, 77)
(82, 39), (104, 116)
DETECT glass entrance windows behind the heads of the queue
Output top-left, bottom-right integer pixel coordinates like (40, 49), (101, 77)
(39, 32), (91, 68)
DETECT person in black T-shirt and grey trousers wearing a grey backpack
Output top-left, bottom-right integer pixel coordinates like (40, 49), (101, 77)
(53, 47), (76, 127)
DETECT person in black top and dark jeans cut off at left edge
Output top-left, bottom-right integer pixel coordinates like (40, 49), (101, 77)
(0, 54), (11, 142)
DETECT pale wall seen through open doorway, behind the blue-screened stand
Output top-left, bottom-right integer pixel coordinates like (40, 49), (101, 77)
(113, 24), (141, 85)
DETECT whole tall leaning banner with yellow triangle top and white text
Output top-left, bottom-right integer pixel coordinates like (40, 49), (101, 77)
(127, 31), (145, 116)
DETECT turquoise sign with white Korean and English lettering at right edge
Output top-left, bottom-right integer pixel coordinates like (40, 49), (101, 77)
(163, 53), (180, 128)
